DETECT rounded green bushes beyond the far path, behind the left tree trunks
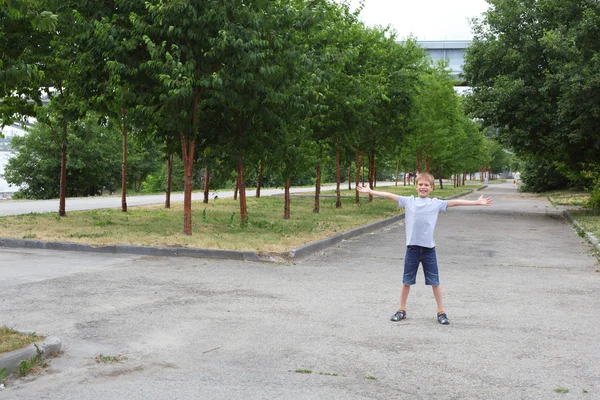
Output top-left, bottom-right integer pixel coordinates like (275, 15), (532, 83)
(5, 116), (158, 199)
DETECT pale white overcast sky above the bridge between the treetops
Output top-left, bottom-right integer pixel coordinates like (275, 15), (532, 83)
(350, 0), (488, 40)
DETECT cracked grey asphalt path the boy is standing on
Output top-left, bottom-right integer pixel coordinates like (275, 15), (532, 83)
(0, 183), (600, 400)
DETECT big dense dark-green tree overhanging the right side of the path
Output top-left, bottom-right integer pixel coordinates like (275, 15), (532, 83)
(464, 0), (600, 207)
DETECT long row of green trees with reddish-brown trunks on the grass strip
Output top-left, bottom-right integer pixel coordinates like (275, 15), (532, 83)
(0, 0), (504, 234)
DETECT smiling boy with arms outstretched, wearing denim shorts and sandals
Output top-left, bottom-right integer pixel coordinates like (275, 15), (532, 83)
(356, 172), (492, 325)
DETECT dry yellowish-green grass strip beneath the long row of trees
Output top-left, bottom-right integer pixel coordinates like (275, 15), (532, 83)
(0, 185), (477, 253)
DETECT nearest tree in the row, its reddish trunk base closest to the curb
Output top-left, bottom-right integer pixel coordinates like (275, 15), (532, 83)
(132, 0), (232, 235)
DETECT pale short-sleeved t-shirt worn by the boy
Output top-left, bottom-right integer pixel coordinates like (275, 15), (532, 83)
(398, 196), (448, 248)
